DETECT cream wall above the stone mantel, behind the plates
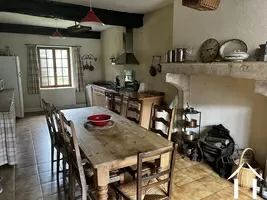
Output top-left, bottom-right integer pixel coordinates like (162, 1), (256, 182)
(173, 0), (267, 56)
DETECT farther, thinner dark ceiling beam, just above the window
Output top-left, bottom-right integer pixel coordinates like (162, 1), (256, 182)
(0, 23), (101, 39)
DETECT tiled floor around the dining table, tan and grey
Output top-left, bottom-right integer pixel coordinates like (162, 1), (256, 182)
(0, 115), (260, 200)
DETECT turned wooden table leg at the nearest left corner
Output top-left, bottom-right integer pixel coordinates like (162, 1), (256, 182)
(95, 167), (109, 200)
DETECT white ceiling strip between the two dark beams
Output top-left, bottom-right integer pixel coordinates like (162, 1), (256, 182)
(0, 12), (112, 32)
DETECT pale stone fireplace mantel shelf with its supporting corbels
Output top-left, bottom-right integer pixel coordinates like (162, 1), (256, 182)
(161, 61), (267, 96)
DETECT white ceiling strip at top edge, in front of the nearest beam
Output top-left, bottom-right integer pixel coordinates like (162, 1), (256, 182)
(53, 0), (173, 14)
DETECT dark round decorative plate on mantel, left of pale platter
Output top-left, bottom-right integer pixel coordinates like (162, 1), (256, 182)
(199, 38), (220, 62)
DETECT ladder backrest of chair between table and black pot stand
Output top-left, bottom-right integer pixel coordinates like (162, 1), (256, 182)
(149, 104), (174, 140)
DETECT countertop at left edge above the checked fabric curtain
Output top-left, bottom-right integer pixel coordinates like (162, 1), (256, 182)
(0, 89), (15, 112)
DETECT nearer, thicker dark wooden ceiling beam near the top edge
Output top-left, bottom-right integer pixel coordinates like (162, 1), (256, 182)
(0, 0), (144, 28)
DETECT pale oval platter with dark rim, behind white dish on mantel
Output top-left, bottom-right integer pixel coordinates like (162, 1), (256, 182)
(220, 39), (248, 58)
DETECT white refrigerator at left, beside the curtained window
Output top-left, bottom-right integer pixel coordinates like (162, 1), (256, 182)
(0, 56), (24, 118)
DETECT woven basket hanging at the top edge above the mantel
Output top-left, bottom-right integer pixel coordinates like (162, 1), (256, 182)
(183, 0), (221, 11)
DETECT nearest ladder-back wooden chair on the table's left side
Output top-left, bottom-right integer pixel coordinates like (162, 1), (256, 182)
(58, 111), (124, 200)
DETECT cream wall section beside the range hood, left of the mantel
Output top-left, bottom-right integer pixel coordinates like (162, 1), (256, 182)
(132, 5), (177, 103)
